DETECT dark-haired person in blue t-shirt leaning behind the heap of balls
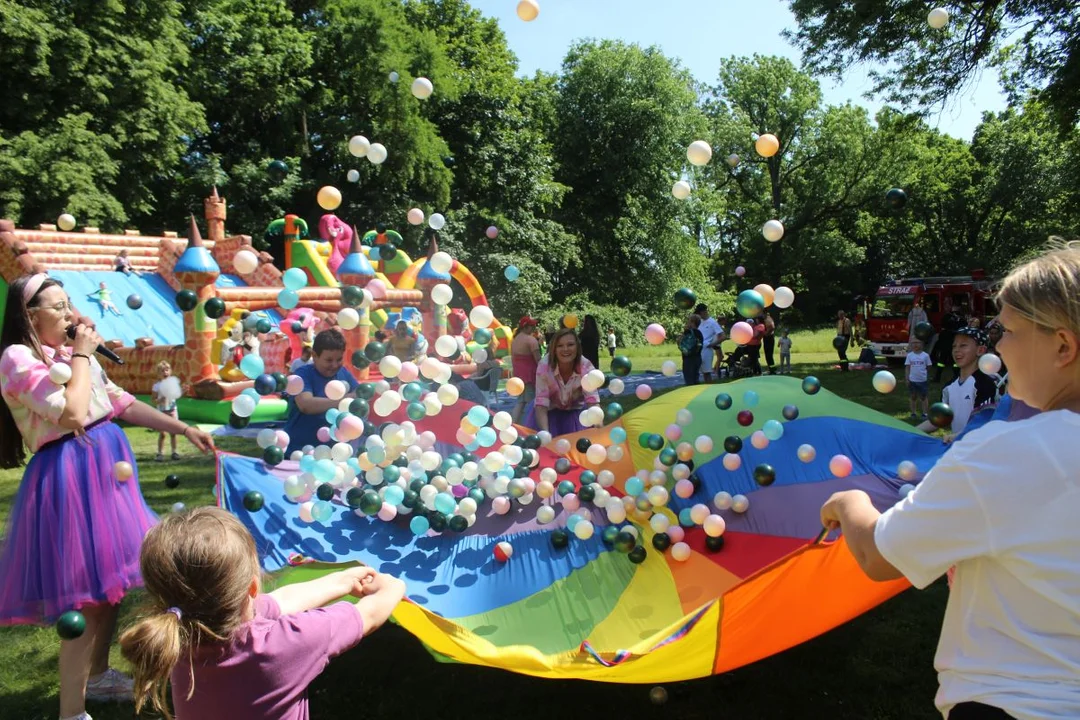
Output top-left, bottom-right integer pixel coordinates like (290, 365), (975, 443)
(282, 328), (360, 457)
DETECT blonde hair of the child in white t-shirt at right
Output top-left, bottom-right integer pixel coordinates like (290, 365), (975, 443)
(996, 237), (1080, 335)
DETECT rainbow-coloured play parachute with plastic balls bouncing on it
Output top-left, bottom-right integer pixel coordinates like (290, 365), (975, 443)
(218, 377), (945, 682)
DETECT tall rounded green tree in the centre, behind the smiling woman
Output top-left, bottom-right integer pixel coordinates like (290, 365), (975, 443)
(553, 41), (710, 311)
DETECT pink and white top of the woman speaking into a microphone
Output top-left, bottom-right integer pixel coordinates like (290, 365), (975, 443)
(0, 345), (135, 452)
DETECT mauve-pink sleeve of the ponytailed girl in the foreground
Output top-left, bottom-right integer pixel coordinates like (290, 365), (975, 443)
(256, 596), (364, 689)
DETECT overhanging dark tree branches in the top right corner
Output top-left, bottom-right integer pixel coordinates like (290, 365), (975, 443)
(786, 0), (1080, 131)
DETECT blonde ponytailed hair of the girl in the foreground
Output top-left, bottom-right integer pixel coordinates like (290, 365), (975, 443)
(120, 507), (259, 720)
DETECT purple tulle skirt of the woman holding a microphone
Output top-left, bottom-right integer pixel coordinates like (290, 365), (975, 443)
(0, 421), (158, 625)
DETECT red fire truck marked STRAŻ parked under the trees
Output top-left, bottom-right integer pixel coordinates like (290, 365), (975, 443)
(855, 270), (997, 364)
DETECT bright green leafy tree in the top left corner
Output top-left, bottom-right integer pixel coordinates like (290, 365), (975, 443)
(0, 0), (205, 230)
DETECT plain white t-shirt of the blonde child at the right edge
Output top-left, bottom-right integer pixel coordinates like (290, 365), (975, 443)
(874, 410), (1080, 720)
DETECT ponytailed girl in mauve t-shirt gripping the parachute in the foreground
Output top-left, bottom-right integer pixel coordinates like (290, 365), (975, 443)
(120, 507), (405, 720)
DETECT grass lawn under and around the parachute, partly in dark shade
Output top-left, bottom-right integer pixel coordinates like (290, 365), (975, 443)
(0, 331), (947, 720)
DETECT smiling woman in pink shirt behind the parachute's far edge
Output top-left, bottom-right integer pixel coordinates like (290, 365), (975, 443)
(526, 328), (600, 436)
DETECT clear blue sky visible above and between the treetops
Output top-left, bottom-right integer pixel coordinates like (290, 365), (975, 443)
(472, 0), (1005, 139)
